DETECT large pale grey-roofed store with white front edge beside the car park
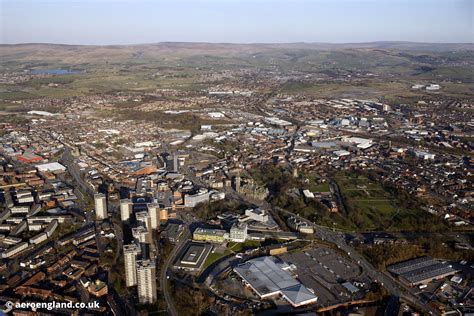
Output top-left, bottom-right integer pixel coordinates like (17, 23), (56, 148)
(234, 256), (318, 307)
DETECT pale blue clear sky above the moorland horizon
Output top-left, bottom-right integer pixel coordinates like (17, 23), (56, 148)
(0, 0), (474, 45)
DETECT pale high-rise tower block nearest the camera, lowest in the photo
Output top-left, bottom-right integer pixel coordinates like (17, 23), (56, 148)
(137, 260), (157, 304)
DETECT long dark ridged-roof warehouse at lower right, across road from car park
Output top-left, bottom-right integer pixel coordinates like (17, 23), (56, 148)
(387, 257), (457, 286)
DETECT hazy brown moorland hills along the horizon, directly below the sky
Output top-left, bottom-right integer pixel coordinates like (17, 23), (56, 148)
(0, 42), (474, 67)
